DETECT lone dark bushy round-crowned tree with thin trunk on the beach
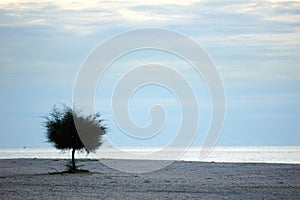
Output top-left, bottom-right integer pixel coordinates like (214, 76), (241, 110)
(43, 106), (106, 170)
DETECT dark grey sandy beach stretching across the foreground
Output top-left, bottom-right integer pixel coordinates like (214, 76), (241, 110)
(0, 159), (300, 199)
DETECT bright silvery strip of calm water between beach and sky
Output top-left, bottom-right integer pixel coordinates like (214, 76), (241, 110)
(0, 146), (300, 164)
